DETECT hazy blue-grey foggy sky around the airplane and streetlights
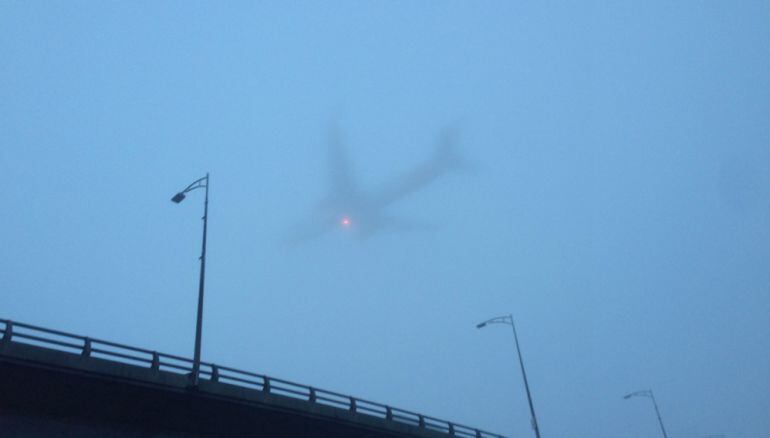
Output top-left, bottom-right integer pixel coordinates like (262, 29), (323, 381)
(0, 0), (770, 438)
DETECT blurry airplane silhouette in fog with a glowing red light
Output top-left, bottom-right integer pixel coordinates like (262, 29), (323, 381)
(288, 128), (466, 243)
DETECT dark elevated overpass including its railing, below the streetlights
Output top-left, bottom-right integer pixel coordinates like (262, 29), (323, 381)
(0, 319), (503, 438)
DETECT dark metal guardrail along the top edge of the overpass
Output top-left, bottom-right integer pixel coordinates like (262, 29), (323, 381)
(0, 319), (505, 438)
